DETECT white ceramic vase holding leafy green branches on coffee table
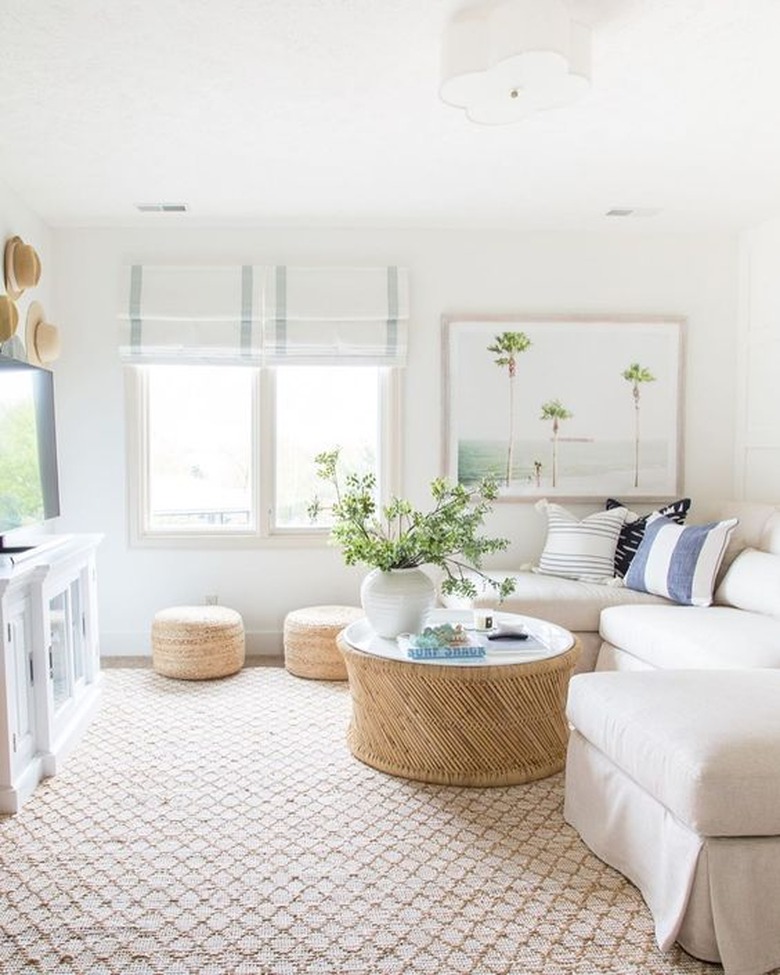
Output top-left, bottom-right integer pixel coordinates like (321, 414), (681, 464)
(360, 568), (436, 639)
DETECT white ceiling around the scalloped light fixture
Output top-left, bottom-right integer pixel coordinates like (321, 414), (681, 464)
(0, 0), (780, 230)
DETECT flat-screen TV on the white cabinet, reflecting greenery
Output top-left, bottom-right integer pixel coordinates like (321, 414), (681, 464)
(0, 356), (60, 535)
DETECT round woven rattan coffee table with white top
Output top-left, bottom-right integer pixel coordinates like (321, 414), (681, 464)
(338, 610), (580, 786)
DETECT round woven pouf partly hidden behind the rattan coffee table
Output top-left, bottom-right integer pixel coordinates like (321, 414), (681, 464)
(284, 606), (365, 680)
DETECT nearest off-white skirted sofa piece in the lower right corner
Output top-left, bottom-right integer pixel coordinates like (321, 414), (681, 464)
(563, 672), (780, 975)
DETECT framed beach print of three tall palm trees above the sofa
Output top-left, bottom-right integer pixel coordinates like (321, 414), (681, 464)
(442, 315), (684, 501)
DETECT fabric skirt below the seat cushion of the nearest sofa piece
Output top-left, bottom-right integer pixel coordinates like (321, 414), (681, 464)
(564, 730), (780, 975)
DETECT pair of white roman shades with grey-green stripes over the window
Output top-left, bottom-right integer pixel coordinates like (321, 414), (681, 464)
(119, 264), (409, 366)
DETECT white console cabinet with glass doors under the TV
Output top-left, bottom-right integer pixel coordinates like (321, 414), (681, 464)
(0, 535), (102, 813)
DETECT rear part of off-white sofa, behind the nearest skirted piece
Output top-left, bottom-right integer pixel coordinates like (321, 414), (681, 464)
(445, 502), (780, 673)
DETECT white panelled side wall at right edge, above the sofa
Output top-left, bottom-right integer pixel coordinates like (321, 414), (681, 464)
(735, 218), (780, 502)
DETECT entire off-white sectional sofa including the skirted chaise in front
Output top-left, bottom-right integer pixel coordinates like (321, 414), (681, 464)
(442, 503), (780, 975)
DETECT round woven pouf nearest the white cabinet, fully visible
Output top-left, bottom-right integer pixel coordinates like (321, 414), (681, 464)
(152, 606), (245, 680)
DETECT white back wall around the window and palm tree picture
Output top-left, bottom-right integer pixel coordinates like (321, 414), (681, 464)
(48, 229), (738, 654)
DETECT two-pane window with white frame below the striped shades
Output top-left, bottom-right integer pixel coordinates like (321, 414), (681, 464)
(127, 364), (397, 544)
